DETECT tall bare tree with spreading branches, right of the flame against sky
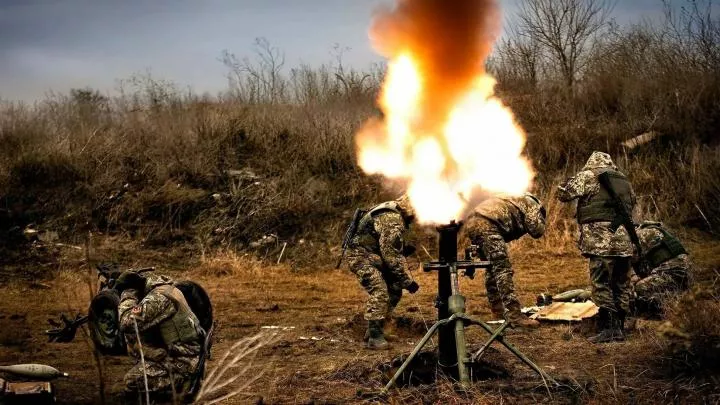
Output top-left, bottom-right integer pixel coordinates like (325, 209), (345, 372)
(518, 0), (615, 89)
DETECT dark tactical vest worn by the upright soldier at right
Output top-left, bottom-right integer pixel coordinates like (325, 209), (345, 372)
(577, 169), (633, 224)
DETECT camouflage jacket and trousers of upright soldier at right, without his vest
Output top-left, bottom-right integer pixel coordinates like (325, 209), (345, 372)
(557, 152), (635, 340)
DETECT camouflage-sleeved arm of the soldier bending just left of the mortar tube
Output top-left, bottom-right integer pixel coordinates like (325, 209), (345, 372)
(374, 212), (412, 288)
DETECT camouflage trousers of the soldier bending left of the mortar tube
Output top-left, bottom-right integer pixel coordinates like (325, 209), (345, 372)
(347, 249), (402, 321)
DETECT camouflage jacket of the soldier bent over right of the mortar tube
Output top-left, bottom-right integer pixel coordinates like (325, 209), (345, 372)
(464, 196), (545, 242)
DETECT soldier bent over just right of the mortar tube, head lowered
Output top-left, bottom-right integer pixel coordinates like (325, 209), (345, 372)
(464, 193), (545, 328)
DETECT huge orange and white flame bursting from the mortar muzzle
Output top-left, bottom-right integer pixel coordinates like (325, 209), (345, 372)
(356, 0), (534, 224)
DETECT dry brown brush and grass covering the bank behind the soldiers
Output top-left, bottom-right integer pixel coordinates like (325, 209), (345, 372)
(0, 4), (720, 266)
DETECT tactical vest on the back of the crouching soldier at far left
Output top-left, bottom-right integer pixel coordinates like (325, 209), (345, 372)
(155, 285), (202, 347)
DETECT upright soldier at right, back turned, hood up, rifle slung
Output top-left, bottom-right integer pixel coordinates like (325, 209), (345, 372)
(557, 152), (635, 343)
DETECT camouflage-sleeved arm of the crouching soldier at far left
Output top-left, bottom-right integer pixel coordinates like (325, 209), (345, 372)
(118, 290), (176, 333)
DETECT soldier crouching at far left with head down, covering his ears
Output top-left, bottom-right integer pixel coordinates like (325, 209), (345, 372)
(115, 271), (205, 398)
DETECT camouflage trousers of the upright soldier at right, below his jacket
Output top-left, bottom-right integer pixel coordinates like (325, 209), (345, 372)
(589, 256), (630, 314)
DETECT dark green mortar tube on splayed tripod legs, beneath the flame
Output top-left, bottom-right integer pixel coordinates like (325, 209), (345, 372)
(382, 221), (559, 394)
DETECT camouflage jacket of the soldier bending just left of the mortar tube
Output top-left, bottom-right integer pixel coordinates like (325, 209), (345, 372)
(350, 211), (412, 286)
